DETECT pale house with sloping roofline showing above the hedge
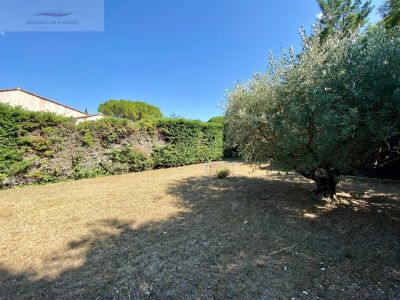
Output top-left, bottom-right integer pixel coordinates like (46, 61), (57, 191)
(0, 88), (104, 123)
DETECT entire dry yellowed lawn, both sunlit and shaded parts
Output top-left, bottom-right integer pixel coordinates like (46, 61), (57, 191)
(0, 163), (400, 299)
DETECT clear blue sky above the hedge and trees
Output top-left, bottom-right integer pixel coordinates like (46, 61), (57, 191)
(0, 0), (381, 120)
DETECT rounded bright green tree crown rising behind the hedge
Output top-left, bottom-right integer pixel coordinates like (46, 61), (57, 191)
(99, 100), (162, 121)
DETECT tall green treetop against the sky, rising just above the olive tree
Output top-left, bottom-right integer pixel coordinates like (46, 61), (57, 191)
(317, 0), (372, 42)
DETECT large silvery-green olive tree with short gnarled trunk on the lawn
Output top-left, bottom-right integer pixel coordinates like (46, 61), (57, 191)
(226, 29), (400, 196)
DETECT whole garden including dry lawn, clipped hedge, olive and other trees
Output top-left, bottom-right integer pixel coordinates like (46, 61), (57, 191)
(0, 0), (400, 299)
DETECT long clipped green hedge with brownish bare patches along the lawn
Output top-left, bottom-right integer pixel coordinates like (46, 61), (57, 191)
(0, 105), (223, 188)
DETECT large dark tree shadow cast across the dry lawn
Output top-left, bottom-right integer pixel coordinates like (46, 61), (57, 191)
(0, 177), (400, 299)
